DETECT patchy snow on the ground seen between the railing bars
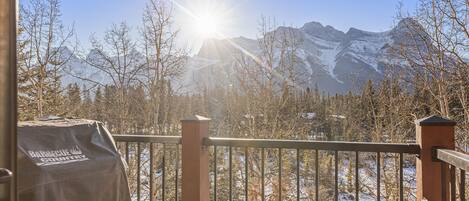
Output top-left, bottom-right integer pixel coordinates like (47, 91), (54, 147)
(119, 147), (416, 201)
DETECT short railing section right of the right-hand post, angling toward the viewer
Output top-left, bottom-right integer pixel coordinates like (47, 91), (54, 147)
(435, 149), (469, 201)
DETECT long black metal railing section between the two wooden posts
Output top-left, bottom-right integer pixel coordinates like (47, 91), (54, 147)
(205, 138), (420, 200)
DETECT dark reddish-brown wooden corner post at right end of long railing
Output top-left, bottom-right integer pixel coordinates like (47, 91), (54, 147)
(415, 116), (456, 201)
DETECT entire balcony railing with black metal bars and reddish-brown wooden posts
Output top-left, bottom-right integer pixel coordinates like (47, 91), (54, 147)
(114, 117), (469, 201)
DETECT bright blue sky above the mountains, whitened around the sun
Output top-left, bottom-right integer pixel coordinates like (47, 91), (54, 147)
(20, 0), (417, 52)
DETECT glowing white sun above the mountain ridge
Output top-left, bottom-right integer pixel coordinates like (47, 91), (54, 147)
(195, 14), (220, 38)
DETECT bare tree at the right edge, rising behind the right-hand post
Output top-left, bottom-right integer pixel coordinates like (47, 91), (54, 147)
(398, 0), (469, 148)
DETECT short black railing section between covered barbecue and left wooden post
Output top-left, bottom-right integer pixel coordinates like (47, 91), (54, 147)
(113, 135), (181, 201)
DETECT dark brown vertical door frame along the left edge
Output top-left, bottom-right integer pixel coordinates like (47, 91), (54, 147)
(0, 0), (17, 201)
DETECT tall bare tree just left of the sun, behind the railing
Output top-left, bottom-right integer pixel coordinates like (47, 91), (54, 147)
(142, 0), (187, 133)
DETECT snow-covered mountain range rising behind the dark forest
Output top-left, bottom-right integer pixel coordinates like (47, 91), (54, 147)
(62, 19), (415, 93)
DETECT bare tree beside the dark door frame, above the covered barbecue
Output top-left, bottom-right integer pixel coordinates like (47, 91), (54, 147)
(18, 0), (76, 118)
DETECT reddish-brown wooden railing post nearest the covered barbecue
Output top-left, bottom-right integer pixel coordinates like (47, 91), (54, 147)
(181, 115), (210, 201)
